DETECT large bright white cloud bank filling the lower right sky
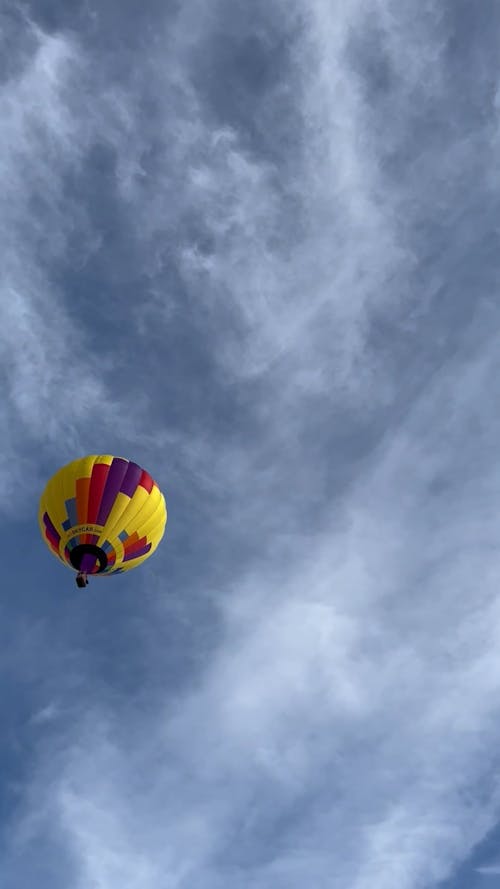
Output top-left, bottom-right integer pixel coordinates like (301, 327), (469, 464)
(8, 318), (500, 889)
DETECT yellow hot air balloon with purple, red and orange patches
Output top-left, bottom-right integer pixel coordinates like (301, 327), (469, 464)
(38, 454), (167, 587)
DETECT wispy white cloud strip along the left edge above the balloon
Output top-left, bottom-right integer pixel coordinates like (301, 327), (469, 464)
(0, 22), (105, 506)
